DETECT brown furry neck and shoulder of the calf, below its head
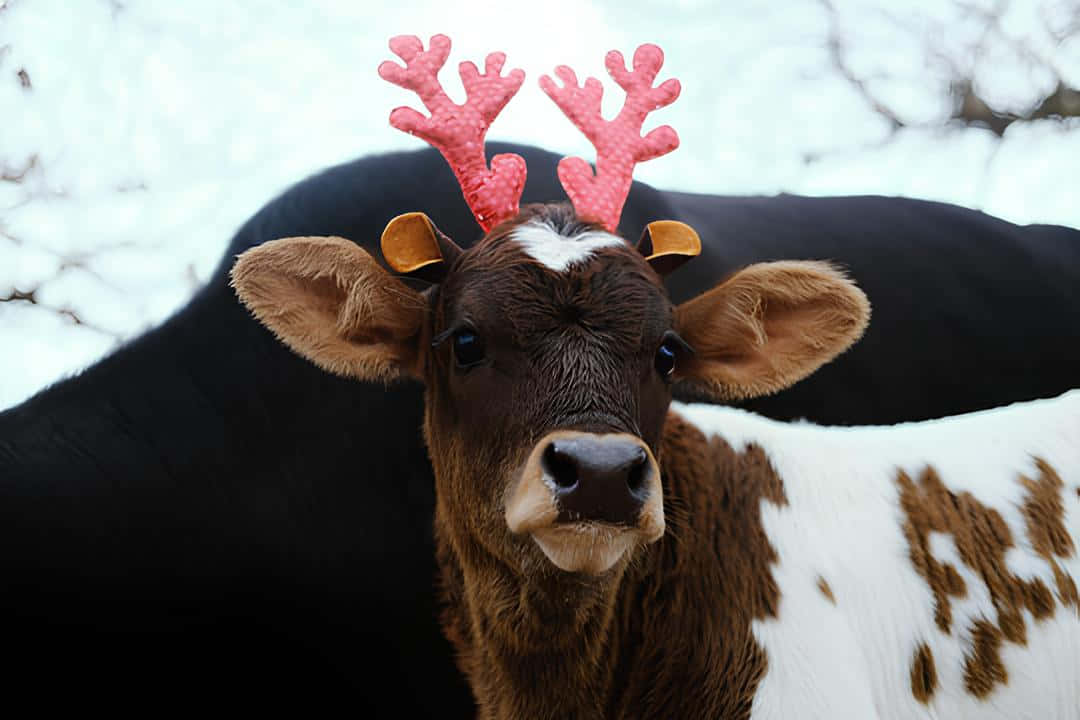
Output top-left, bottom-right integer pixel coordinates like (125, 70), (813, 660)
(440, 415), (786, 718)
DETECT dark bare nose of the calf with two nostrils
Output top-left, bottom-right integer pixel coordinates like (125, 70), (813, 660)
(541, 433), (652, 525)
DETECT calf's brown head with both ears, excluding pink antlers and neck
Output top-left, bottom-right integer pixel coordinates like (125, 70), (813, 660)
(232, 205), (868, 574)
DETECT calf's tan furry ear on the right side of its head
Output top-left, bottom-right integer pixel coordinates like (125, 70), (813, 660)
(675, 261), (870, 402)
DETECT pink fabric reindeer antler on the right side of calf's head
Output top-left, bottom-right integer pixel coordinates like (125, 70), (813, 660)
(540, 44), (681, 232)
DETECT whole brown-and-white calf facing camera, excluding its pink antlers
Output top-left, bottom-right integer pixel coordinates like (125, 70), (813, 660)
(233, 206), (1080, 720)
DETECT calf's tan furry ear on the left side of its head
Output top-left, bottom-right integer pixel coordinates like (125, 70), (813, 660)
(231, 237), (427, 381)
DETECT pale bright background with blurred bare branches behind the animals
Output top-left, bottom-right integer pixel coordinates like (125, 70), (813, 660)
(0, 0), (1080, 408)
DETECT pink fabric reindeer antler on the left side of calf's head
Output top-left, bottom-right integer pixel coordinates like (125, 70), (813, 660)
(379, 35), (525, 232)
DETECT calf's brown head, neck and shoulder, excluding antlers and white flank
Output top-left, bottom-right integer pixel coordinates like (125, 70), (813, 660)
(232, 199), (869, 718)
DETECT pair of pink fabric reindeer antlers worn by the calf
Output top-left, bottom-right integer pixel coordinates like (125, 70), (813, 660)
(379, 35), (680, 232)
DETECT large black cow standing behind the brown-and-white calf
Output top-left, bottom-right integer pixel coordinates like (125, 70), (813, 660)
(0, 144), (1080, 718)
